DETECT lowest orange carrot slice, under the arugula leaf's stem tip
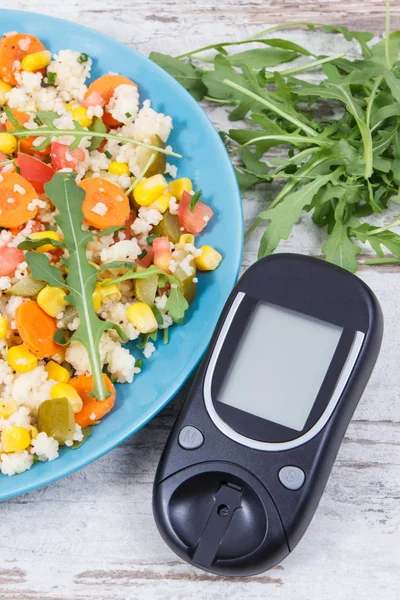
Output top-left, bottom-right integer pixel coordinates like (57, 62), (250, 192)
(68, 373), (117, 427)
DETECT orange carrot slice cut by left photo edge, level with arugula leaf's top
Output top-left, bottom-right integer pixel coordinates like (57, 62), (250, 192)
(0, 172), (38, 227)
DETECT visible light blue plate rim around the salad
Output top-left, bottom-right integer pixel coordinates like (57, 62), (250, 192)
(0, 9), (243, 500)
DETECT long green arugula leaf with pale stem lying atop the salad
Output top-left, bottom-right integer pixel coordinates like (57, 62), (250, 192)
(20, 173), (127, 400)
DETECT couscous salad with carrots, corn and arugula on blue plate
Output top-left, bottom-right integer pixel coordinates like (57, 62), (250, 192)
(0, 32), (222, 475)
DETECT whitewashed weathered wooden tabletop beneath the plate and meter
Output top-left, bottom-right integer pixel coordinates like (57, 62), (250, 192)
(0, 0), (400, 600)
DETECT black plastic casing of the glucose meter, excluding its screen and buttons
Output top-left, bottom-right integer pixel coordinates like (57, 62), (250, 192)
(153, 254), (383, 576)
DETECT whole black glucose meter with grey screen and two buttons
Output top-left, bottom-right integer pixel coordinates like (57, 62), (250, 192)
(153, 254), (383, 575)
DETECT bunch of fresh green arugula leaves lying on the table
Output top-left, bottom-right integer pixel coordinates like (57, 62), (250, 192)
(150, 1), (400, 272)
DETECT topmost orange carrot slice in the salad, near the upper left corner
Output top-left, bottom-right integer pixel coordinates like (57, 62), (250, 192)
(0, 33), (46, 85)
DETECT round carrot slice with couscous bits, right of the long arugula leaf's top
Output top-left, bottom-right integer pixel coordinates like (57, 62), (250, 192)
(79, 177), (130, 229)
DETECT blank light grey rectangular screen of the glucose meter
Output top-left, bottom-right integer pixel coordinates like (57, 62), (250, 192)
(218, 302), (343, 431)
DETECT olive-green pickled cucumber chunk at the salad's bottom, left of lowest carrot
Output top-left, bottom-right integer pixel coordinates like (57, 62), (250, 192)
(38, 398), (75, 444)
